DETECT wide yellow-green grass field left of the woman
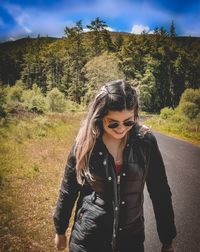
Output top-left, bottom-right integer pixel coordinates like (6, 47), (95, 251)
(0, 113), (82, 252)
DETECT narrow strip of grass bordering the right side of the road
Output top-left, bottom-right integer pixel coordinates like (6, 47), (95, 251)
(144, 115), (200, 145)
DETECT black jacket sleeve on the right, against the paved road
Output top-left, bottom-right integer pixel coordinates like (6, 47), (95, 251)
(146, 133), (176, 244)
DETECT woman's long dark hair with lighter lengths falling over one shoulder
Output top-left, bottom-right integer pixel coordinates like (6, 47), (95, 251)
(75, 80), (138, 184)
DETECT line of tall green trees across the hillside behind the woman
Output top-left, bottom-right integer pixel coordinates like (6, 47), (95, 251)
(0, 18), (200, 112)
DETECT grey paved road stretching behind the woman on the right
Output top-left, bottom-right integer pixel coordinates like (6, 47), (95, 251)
(144, 133), (200, 252)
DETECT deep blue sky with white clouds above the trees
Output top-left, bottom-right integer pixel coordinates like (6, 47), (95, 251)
(0, 0), (200, 40)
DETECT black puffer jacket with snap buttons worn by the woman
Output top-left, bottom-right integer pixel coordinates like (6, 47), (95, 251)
(54, 125), (176, 252)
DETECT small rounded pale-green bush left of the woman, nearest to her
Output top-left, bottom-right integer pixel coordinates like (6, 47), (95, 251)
(47, 88), (66, 112)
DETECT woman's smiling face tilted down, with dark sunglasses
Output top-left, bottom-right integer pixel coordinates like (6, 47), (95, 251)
(103, 110), (134, 140)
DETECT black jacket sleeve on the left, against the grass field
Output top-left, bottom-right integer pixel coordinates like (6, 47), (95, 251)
(53, 147), (80, 234)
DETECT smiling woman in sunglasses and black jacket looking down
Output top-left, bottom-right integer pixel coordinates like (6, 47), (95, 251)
(54, 80), (176, 252)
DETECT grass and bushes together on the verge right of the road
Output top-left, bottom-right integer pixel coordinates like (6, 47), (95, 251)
(145, 89), (200, 144)
